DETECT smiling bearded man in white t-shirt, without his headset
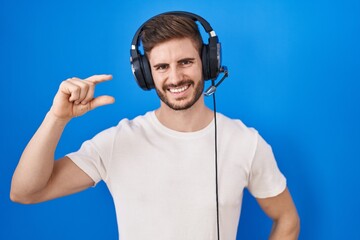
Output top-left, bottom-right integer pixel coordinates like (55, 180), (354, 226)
(11, 11), (299, 240)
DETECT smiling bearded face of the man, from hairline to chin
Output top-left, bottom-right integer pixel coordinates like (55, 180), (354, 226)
(148, 38), (204, 110)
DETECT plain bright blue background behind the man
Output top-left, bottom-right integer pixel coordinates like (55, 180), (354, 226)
(0, 0), (360, 240)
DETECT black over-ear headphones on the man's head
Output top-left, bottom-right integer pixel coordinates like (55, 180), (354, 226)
(130, 11), (221, 90)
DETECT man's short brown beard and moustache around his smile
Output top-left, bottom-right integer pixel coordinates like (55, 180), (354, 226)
(155, 80), (204, 111)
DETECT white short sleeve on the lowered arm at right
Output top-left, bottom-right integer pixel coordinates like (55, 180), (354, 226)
(248, 135), (286, 198)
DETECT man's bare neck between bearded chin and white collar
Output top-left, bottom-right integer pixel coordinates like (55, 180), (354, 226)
(155, 97), (213, 132)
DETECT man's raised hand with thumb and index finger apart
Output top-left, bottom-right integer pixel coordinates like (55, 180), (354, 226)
(50, 74), (115, 120)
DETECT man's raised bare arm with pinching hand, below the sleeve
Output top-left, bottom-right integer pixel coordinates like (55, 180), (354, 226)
(10, 75), (114, 203)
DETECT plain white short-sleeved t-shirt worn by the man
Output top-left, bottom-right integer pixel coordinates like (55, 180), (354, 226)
(68, 112), (286, 240)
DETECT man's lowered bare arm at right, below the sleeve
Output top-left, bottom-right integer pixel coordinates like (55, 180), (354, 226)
(256, 188), (300, 240)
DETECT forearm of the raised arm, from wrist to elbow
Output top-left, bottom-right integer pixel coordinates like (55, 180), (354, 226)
(11, 112), (67, 201)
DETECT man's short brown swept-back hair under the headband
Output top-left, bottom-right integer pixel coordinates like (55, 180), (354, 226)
(140, 14), (203, 56)
